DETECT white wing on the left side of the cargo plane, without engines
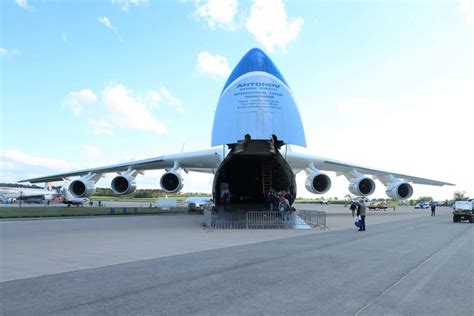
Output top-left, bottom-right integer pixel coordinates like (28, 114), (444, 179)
(19, 149), (222, 183)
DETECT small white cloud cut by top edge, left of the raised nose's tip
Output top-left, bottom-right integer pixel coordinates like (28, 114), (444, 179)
(193, 0), (238, 29)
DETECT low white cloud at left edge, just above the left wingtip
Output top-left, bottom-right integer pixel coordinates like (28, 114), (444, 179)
(0, 149), (72, 170)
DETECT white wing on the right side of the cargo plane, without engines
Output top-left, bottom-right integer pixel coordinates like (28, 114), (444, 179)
(286, 152), (455, 186)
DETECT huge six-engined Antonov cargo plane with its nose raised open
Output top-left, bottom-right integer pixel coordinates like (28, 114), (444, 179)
(21, 48), (453, 209)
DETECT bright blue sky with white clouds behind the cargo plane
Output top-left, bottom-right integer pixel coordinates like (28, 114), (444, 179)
(0, 0), (474, 199)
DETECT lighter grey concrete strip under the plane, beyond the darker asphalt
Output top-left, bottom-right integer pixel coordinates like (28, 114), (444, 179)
(0, 202), (429, 282)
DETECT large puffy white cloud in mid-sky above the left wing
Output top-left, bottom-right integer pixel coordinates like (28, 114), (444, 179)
(63, 83), (176, 135)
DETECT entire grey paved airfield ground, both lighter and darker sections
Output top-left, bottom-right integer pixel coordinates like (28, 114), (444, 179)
(0, 205), (474, 315)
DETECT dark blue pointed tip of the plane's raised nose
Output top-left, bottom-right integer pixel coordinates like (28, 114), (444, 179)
(221, 48), (288, 94)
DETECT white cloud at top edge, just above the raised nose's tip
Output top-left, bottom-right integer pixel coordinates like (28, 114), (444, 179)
(246, 0), (303, 51)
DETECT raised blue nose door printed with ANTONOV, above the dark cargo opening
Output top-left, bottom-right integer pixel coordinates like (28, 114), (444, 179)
(211, 48), (306, 147)
